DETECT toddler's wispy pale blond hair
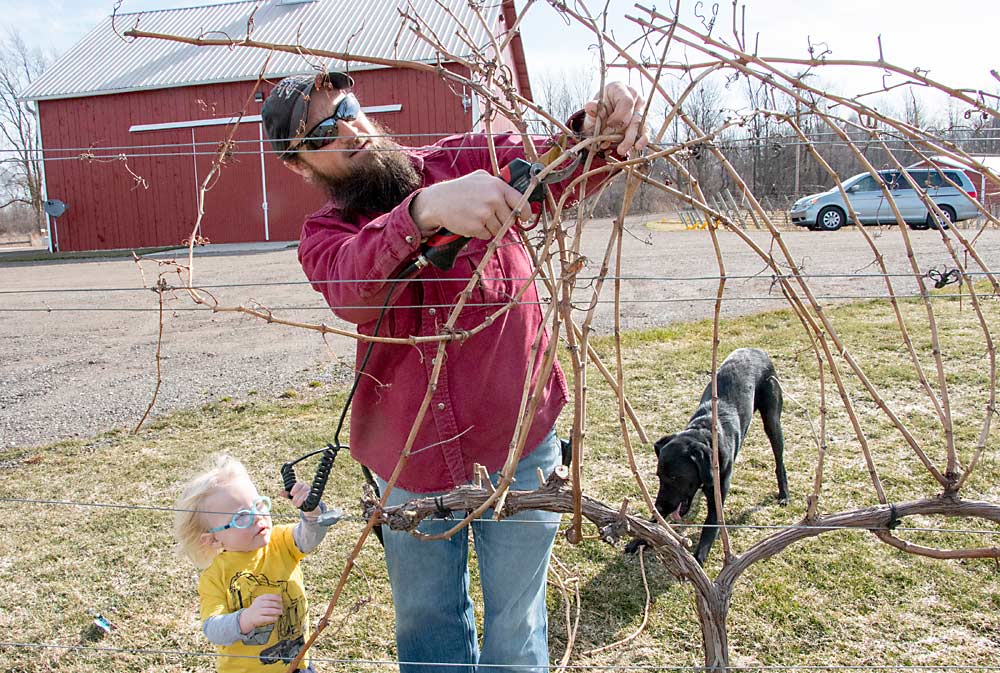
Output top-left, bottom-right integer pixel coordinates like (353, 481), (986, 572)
(174, 454), (250, 570)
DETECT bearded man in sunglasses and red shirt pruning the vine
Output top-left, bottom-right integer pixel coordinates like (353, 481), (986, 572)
(262, 72), (646, 673)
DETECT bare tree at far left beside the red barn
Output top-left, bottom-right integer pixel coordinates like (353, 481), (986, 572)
(0, 31), (47, 228)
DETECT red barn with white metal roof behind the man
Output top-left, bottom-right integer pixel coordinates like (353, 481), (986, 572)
(22, 0), (531, 250)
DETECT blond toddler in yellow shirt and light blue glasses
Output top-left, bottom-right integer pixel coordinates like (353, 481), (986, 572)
(174, 456), (326, 673)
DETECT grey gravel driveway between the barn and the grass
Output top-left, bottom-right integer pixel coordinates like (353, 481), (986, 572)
(0, 222), (1000, 448)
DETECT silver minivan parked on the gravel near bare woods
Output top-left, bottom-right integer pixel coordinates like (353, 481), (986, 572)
(791, 168), (979, 231)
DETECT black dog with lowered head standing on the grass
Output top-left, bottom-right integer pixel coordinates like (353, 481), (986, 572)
(625, 348), (788, 565)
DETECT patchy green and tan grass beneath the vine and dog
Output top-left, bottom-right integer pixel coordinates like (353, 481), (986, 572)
(0, 290), (1000, 673)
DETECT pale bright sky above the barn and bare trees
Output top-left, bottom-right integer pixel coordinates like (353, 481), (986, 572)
(0, 0), (1000, 109)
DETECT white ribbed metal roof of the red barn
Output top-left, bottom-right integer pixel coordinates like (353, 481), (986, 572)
(21, 0), (500, 100)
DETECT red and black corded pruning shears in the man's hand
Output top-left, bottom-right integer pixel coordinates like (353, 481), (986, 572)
(411, 145), (582, 273)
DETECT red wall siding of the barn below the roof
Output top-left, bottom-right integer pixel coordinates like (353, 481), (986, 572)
(39, 54), (552, 250)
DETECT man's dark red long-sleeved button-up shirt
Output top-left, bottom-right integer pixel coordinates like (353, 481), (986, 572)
(299, 134), (600, 493)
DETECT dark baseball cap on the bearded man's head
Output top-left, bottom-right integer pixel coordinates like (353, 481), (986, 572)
(260, 70), (354, 159)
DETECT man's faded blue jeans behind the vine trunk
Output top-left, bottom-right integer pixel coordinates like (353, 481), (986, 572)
(377, 431), (562, 673)
